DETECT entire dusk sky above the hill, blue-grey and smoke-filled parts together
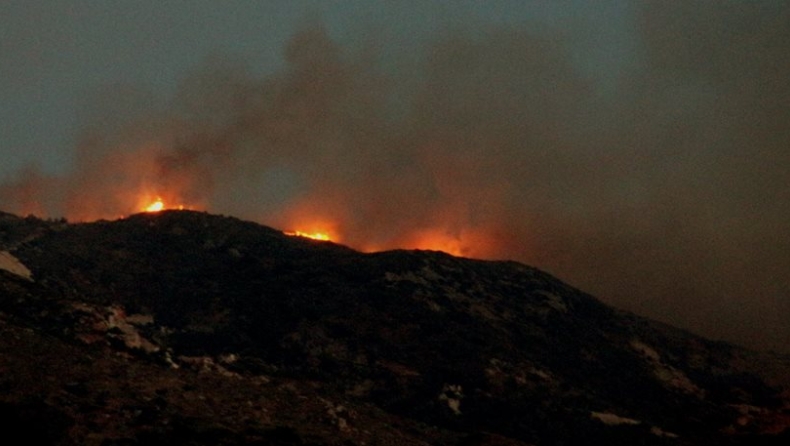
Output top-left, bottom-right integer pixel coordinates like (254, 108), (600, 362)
(0, 0), (790, 352)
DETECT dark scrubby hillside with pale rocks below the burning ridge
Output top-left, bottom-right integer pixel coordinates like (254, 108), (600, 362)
(0, 211), (790, 445)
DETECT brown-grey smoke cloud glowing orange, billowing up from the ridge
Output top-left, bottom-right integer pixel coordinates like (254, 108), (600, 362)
(0, 1), (790, 351)
